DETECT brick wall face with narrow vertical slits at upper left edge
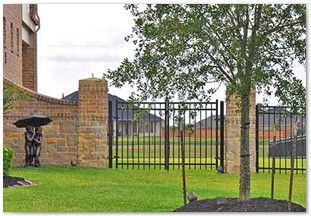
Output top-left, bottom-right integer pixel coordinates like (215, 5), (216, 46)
(3, 4), (22, 85)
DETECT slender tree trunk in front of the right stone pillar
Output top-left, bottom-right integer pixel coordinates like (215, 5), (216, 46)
(239, 91), (250, 201)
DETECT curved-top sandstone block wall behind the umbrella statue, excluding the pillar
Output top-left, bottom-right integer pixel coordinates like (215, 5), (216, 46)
(3, 78), (78, 166)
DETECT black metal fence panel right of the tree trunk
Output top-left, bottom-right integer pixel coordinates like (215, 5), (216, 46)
(256, 105), (307, 173)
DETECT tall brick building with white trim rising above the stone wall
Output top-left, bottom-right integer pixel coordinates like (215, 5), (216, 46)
(3, 4), (40, 91)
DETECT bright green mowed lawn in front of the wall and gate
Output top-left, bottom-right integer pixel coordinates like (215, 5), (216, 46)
(3, 166), (306, 212)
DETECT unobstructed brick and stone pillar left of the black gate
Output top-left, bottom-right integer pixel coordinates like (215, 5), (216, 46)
(77, 78), (108, 167)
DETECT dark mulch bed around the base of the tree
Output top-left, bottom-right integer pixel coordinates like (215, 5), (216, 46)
(174, 197), (306, 212)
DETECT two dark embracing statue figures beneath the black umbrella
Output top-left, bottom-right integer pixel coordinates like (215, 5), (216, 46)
(25, 126), (42, 167)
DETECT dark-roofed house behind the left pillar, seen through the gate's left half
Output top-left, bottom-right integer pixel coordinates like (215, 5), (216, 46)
(62, 91), (164, 137)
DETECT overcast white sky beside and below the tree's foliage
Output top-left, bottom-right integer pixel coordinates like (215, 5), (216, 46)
(38, 4), (306, 103)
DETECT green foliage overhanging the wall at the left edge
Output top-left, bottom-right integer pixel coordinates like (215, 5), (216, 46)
(3, 81), (28, 114)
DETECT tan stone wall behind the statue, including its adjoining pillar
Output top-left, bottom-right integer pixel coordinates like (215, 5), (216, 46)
(3, 79), (108, 167)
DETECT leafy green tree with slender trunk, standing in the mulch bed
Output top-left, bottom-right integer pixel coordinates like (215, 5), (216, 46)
(106, 4), (306, 200)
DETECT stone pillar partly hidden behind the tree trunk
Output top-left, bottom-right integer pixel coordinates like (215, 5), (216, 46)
(225, 89), (256, 174)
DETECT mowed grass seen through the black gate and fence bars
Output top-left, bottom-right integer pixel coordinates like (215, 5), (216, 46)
(112, 137), (307, 172)
